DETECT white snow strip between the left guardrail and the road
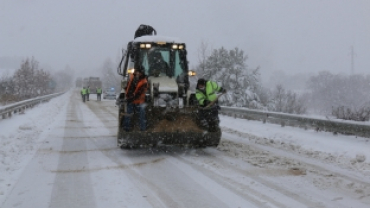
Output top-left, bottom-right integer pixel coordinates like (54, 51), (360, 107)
(0, 91), (71, 200)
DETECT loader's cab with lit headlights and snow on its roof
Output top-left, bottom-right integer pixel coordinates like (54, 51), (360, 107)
(118, 35), (195, 106)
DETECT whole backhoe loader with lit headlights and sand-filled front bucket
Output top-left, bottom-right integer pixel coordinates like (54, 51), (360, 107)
(117, 25), (221, 148)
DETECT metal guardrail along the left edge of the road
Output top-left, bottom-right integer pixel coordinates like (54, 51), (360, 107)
(0, 92), (64, 119)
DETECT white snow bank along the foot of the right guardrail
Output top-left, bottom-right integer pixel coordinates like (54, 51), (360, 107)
(220, 116), (370, 175)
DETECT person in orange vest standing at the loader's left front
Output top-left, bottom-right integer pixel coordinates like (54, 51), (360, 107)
(124, 67), (148, 131)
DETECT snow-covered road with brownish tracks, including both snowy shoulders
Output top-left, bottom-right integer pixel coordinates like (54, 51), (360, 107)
(0, 91), (370, 208)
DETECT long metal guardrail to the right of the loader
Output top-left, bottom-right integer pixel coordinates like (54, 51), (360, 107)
(220, 106), (370, 138)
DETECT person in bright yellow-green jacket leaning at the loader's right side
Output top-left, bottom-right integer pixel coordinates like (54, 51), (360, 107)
(195, 79), (226, 128)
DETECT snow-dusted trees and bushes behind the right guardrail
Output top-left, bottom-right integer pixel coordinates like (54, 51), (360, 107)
(193, 43), (370, 121)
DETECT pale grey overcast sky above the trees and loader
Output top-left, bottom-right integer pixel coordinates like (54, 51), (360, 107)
(0, 0), (370, 79)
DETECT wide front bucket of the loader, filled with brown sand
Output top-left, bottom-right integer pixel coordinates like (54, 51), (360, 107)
(117, 108), (221, 148)
